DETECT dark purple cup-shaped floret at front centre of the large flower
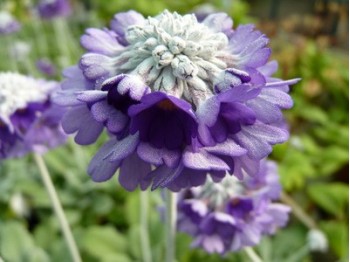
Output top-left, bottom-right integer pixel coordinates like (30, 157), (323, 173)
(129, 92), (197, 150)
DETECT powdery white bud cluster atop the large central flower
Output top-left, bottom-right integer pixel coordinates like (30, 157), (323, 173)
(115, 11), (230, 106)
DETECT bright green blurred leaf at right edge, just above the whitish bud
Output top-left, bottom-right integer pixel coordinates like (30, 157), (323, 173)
(307, 183), (349, 218)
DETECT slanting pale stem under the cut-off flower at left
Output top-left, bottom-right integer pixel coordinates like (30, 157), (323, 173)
(34, 154), (82, 262)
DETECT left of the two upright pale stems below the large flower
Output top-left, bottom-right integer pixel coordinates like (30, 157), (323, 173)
(140, 191), (152, 262)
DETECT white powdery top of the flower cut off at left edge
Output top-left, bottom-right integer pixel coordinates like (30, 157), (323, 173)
(0, 72), (51, 124)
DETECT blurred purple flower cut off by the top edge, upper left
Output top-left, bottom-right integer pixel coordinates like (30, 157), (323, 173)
(37, 0), (71, 19)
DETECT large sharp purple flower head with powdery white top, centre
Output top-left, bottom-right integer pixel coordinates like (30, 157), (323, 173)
(55, 11), (298, 191)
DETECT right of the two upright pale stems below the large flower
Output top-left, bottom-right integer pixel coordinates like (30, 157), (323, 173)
(165, 190), (177, 262)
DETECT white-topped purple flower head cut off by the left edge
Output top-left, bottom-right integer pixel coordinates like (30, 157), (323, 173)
(0, 72), (66, 160)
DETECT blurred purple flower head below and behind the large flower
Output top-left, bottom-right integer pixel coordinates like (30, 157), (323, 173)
(178, 161), (290, 254)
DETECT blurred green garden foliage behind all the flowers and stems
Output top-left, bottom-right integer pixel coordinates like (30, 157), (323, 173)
(0, 0), (349, 262)
